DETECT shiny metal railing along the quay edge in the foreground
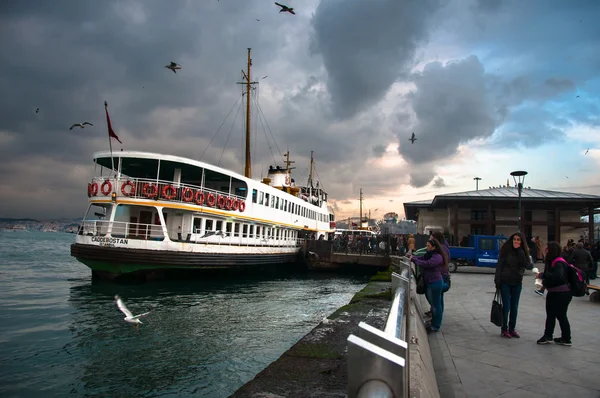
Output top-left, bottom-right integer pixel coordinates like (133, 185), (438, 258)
(347, 258), (411, 398)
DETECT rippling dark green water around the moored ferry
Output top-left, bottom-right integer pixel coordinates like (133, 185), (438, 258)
(0, 232), (366, 398)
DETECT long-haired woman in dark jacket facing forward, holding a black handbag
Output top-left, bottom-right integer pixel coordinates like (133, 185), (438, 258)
(494, 232), (533, 339)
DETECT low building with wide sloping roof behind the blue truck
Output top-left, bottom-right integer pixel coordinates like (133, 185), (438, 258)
(404, 186), (600, 244)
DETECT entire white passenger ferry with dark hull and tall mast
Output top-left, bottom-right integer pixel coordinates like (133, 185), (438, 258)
(71, 49), (335, 279)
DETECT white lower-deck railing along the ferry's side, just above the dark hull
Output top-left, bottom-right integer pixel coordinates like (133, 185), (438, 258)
(78, 220), (304, 248)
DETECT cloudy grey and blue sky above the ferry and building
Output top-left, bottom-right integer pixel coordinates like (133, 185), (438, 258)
(0, 0), (600, 219)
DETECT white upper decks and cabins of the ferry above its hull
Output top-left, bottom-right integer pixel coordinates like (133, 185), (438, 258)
(79, 151), (335, 252)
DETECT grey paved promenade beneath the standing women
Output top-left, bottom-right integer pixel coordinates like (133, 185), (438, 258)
(421, 268), (600, 398)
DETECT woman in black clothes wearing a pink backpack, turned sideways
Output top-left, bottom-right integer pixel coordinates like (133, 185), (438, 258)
(537, 242), (573, 345)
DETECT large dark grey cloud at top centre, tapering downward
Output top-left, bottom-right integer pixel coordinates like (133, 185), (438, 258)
(313, 0), (441, 118)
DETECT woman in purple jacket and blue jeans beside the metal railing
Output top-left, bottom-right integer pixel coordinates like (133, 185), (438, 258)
(409, 237), (448, 334)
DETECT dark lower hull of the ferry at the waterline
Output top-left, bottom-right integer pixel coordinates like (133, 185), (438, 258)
(71, 243), (299, 280)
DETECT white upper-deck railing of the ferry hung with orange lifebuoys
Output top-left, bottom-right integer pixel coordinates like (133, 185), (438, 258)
(92, 176), (246, 203)
